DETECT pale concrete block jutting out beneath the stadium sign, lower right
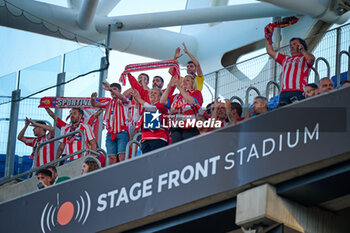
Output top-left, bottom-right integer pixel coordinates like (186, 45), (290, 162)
(236, 184), (344, 233)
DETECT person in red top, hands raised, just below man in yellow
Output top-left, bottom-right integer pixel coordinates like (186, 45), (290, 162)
(160, 75), (203, 143)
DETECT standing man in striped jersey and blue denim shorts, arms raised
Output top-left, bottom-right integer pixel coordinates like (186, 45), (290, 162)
(91, 82), (129, 164)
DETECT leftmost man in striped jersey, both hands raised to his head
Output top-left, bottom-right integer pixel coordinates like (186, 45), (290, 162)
(17, 118), (55, 167)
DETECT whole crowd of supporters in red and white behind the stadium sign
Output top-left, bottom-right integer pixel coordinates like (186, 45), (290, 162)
(18, 26), (349, 187)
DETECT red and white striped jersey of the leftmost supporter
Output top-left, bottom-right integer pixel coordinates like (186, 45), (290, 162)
(25, 133), (55, 167)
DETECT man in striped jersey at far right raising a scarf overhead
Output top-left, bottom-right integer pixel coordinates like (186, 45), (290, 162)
(265, 26), (315, 105)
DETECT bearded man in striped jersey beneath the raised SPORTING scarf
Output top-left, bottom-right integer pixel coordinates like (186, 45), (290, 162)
(56, 108), (96, 160)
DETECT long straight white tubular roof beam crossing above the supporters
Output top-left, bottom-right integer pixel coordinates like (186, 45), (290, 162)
(95, 3), (293, 32)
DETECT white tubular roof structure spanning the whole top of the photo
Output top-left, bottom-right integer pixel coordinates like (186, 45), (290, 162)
(0, 0), (350, 72)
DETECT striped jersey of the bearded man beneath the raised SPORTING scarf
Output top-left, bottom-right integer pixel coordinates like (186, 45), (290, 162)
(60, 123), (94, 160)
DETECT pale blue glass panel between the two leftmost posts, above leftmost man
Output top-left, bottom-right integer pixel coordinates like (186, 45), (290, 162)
(19, 56), (62, 97)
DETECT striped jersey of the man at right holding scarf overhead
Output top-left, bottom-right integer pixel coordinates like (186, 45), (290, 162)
(275, 52), (312, 92)
